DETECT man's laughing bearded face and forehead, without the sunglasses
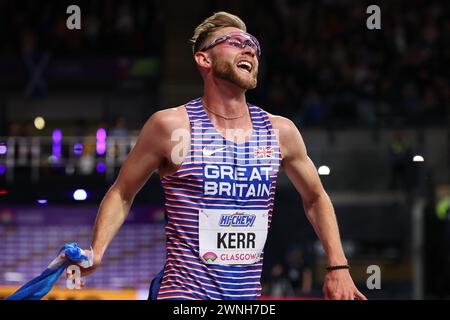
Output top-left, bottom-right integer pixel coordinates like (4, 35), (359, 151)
(202, 27), (259, 90)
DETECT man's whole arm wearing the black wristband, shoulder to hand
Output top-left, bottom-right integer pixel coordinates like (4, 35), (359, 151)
(271, 117), (366, 300)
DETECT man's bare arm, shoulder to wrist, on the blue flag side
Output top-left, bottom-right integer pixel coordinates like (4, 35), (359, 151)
(92, 108), (187, 264)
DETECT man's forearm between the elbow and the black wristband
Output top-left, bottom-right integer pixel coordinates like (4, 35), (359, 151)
(304, 192), (347, 265)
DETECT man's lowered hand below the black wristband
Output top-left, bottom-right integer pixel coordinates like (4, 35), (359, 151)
(323, 269), (367, 300)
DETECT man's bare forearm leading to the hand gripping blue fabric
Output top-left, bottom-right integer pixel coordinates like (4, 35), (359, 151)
(92, 187), (132, 261)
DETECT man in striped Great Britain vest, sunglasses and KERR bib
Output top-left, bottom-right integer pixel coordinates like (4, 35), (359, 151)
(64, 12), (365, 299)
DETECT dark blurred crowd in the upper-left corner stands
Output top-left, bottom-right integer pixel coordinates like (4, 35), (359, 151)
(0, 0), (164, 56)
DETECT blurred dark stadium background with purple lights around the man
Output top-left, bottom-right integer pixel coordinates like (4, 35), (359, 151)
(0, 0), (450, 299)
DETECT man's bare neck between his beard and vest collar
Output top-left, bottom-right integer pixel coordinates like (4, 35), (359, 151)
(203, 79), (247, 118)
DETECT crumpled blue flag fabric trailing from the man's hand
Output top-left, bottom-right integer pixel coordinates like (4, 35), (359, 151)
(4, 242), (93, 300)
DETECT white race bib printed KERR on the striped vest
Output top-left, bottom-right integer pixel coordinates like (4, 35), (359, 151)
(199, 209), (268, 265)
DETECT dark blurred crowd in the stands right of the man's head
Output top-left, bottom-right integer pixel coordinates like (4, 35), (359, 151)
(243, 0), (450, 127)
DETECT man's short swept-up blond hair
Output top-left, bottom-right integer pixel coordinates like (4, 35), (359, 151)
(190, 11), (247, 53)
